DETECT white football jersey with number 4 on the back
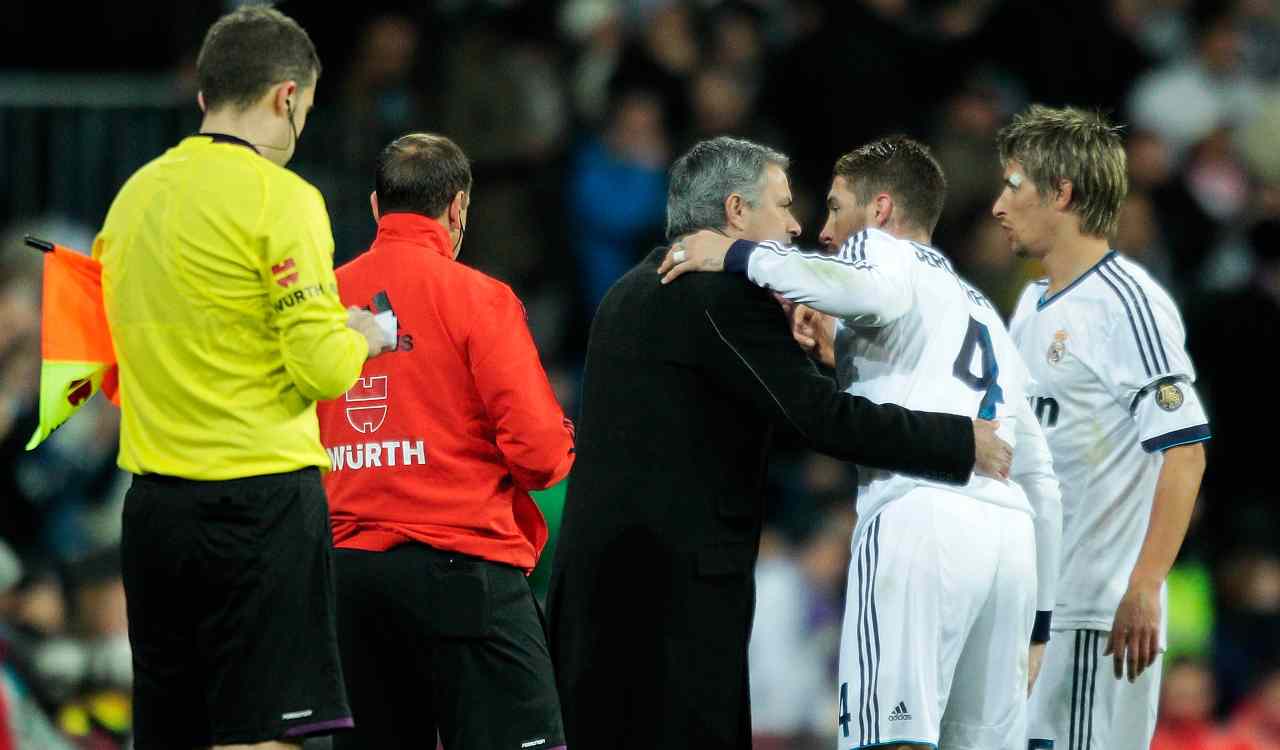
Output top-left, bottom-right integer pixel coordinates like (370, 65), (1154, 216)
(724, 229), (1061, 609)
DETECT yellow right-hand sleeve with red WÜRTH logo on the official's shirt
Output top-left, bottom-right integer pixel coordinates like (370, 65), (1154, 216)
(261, 186), (369, 401)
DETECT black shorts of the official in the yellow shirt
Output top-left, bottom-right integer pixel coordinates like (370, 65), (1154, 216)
(122, 468), (352, 750)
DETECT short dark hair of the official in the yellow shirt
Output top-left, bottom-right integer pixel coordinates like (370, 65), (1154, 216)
(196, 5), (320, 111)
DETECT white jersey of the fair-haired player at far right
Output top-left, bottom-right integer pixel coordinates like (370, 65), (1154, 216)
(1010, 251), (1210, 630)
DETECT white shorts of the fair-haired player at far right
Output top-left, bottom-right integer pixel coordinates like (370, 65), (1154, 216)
(1027, 630), (1164, 750)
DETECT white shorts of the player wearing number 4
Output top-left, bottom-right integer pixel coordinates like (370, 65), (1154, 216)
(836, 488), (1036, 750)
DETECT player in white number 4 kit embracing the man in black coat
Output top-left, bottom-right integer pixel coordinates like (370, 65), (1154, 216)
(660, 137), (1061, 750)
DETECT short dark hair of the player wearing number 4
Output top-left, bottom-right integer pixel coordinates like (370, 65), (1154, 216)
(832, 136), (947, 234)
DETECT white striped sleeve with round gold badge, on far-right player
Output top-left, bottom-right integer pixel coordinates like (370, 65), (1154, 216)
(1097, 264), (1210, 453)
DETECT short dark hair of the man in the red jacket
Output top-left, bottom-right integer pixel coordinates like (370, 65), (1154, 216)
(374, 133), (471, 219)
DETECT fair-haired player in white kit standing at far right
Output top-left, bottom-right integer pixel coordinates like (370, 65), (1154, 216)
(992, 106), (1210, 750)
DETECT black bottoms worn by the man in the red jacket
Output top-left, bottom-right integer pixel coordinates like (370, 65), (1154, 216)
(334, 544), (564, 750)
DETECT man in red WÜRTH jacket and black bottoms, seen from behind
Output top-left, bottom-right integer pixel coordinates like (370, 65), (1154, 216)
(317, 133), (573, 750)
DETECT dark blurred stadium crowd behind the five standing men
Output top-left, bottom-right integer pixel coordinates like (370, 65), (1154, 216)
(0, 0), (1280, 750)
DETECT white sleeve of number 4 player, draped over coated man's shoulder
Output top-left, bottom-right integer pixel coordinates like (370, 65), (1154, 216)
(724, 229), (913, 325)
